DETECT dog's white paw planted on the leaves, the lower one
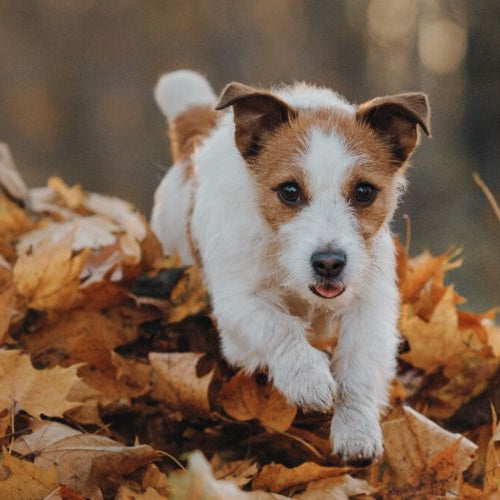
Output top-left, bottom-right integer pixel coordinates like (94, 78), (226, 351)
(330, 408), (384, 467)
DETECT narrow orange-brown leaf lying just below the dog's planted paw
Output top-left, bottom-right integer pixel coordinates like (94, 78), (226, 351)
(252, 462), (352, 493)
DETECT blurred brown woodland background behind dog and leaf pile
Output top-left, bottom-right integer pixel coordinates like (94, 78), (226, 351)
(0, 0), (500, 310)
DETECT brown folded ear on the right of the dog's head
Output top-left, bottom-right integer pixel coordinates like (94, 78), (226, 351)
(356, 92), (430, 166)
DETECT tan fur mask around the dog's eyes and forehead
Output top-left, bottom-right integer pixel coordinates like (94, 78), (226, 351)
(247, 109), (397, 244)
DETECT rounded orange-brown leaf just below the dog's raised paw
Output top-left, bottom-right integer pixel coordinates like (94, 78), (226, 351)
(218, 371), (297, 432)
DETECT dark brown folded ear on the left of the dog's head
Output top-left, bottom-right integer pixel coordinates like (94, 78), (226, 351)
(215, 83), (297, 159)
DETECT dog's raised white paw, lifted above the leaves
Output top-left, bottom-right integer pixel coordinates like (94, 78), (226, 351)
(270, 348), (337, 411)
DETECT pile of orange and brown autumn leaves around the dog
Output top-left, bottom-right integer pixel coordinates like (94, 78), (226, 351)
(0, 145), (500, 500)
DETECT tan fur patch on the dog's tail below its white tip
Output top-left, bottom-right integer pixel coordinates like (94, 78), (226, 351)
(168, 106), (218, 166)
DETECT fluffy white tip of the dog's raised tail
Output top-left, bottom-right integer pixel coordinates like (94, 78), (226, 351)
(155, 69), (216, 120)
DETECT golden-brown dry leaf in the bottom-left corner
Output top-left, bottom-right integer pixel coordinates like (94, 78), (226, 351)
(0, 452), (59, 500)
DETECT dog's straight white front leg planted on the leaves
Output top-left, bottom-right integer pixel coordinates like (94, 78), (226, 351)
(331, 258), (398, 465)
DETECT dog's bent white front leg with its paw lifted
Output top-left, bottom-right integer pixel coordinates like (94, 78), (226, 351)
(214, 294), (337, 411)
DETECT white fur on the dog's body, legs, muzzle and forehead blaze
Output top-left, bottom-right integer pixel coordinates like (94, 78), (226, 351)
(153, 72), (398, 459)
